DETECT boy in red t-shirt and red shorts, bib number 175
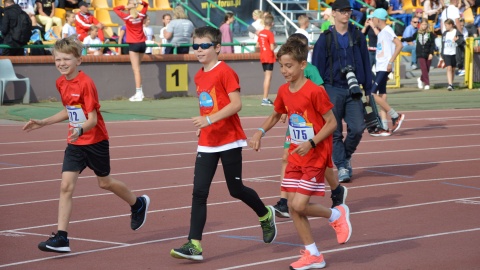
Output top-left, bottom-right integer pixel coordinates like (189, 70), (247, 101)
(249, 40), (352, 269)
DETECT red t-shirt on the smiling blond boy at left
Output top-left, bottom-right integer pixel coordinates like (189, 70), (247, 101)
(56, 71), (108, 145)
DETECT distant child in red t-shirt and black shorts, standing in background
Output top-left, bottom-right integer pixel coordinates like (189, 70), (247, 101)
(258, 15), (276, 106)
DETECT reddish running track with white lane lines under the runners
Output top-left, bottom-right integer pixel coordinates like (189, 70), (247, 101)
(0, 109), (480, 269)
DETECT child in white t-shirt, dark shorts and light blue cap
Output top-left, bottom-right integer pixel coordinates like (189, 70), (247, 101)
(370, 8), (405, 137)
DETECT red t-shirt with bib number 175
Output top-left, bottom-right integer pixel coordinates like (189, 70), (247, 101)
(274, 80), (333, 168)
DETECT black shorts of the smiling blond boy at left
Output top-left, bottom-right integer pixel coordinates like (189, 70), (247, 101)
(62, 140), (110, 177)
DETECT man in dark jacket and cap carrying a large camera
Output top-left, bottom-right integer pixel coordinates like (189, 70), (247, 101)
(312, 0), (372, 182)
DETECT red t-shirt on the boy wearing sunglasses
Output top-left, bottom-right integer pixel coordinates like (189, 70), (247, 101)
(194, 62), (247, 147)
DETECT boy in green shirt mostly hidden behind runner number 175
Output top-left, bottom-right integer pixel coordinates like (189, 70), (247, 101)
(273, 33), (348, 218)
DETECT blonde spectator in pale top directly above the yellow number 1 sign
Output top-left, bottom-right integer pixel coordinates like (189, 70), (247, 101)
(163, 6), (195, 54)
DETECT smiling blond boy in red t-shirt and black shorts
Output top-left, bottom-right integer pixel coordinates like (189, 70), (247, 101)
(23, 37), (150, 253)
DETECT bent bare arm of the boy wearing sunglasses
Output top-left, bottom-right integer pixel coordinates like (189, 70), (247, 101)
(192, 90), (242, 128)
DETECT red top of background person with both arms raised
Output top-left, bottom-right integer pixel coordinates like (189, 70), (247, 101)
(113, 2), (148, 43)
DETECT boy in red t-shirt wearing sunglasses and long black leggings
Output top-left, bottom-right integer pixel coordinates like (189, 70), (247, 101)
(170, 26), (277, 261)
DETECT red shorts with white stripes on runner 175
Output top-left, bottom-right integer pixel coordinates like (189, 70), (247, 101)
(281, 163), (326, 196)
